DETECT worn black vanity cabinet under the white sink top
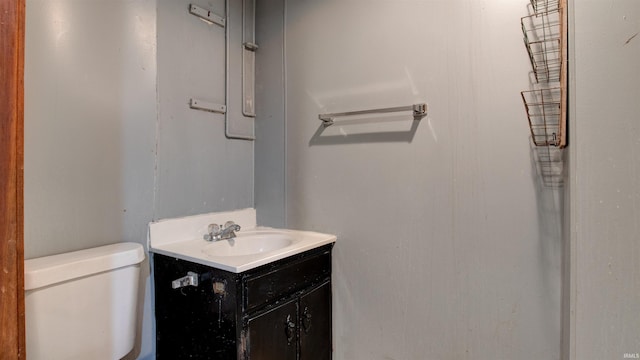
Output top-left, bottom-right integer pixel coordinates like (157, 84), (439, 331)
(153, 244), (333, 360)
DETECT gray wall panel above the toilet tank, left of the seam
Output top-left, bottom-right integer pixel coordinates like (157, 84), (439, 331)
(25, 0), (156, 258)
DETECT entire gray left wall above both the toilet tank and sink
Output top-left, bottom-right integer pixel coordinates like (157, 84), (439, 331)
(25, 0), (253, 358)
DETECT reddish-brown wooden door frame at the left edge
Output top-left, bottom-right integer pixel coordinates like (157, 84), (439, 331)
(0, 0), (26, 360)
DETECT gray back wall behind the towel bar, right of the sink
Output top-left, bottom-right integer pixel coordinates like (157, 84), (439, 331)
(256, 0), (561, 360)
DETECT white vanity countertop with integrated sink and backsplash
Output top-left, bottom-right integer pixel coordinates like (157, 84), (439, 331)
(149, 209), (336, 273)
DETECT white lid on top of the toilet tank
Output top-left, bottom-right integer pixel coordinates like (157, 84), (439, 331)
(24, 242), (144, 290)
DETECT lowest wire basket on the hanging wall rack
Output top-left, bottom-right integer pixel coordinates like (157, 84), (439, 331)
(520, 87), (563, 147)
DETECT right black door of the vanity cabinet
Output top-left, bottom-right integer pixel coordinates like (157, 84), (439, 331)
(299, 282), (332, 360)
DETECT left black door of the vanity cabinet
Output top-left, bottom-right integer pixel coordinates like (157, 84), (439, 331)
(245, 299), (298, 360)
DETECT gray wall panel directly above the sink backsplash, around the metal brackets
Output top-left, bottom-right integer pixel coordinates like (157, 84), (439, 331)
(155, 0), (253, 219)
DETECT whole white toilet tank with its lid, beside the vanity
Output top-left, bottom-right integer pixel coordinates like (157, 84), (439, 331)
(24, 243), (144, 360)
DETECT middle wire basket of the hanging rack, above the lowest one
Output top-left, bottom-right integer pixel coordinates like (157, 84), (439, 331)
(520, 8), (562, 82)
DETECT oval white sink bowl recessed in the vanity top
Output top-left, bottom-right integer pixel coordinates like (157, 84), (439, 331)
(202, 230), (295, 256)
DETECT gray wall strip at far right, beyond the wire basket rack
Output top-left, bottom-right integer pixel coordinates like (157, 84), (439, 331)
(565, 0), (640, 360)
